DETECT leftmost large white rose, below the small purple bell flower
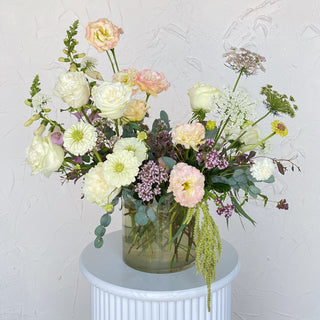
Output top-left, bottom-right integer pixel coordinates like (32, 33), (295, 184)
(27, 135), (64, 177)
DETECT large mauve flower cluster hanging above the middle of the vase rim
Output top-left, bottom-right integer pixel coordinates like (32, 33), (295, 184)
(135, 160), (169, 201)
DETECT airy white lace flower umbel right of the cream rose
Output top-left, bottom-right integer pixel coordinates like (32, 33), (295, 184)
(213, 87), (257, 129)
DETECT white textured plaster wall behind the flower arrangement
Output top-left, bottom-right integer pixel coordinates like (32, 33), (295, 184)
(0, 0), (320, 320)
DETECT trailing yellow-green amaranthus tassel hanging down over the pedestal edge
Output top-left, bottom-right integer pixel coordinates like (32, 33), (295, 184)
(194, 202), (221, 311)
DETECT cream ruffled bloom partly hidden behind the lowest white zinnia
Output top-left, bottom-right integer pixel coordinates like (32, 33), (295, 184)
(83, 162), (121, 207)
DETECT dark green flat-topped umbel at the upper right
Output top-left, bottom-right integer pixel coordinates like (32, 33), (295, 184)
(260, 84), (298, 118)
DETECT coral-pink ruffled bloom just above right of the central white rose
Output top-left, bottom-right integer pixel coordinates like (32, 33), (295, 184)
(136, 69), (170, 97)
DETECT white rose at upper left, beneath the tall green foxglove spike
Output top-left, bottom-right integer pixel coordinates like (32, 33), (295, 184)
(53, 72), (90, 108)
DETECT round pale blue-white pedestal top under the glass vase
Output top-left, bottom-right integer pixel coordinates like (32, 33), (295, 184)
(80, 231), (240, 298)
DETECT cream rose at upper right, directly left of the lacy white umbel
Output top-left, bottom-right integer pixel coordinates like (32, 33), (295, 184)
(188, 83), (221, 112)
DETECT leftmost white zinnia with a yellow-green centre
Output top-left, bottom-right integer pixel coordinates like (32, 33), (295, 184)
(63, 122), (97, 156)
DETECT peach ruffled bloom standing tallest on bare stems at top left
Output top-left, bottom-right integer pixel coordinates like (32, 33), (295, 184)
(86, 18), (123, 52)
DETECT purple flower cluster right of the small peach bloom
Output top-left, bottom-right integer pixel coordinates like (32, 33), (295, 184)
(196, 139), (229, 170)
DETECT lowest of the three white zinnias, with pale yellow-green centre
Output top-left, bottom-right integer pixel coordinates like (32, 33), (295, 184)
(103, 150), (139, 188)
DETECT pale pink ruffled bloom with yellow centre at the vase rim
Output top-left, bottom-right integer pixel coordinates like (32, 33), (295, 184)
(168, 162), (205, 208)
